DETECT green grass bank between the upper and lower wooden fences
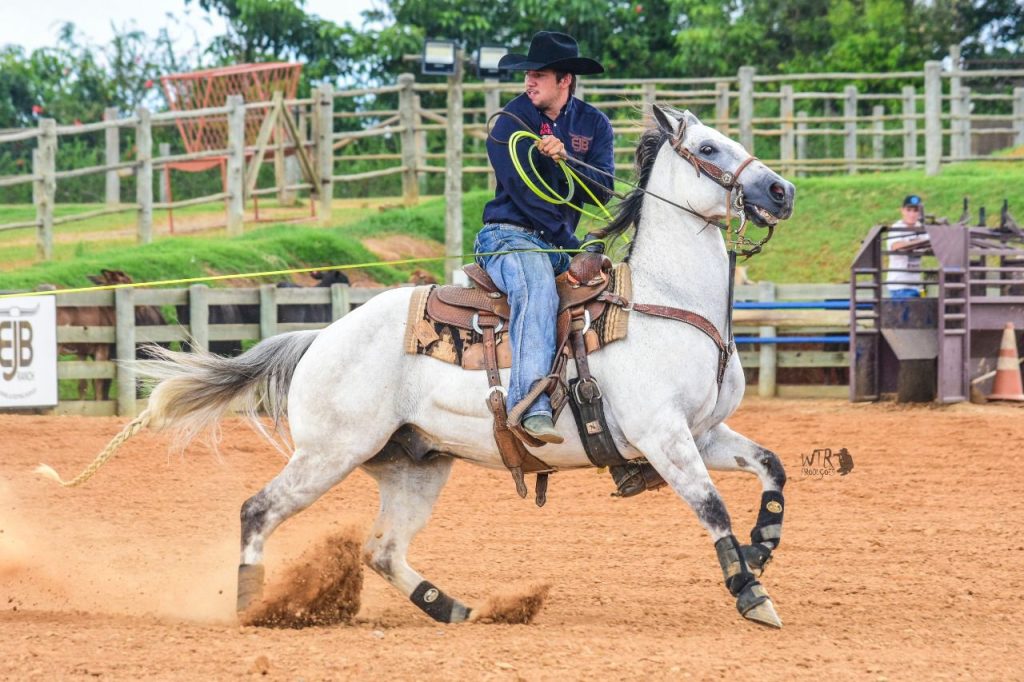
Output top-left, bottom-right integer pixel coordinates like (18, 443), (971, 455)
(0, 158), (1024, 289)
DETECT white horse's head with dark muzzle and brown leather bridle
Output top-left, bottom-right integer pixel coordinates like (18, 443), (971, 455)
(653, 105), (797, 227)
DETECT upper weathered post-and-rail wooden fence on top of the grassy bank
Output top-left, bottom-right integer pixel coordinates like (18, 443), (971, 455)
(0, 49), (1024, 262)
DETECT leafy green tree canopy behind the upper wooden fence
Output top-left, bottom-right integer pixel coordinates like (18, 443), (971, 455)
(0, 0), (1024, 127)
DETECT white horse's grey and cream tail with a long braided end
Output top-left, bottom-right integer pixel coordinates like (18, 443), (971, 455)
(36, 331), (318, 487)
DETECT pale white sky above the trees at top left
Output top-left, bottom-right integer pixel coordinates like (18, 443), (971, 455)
(0, 0), (381, 51)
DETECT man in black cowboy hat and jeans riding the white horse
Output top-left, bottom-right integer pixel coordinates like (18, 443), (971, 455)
(474, 31), (614, 443)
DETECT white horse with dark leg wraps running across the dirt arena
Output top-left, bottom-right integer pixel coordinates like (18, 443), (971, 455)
(44, 109), (795, 627)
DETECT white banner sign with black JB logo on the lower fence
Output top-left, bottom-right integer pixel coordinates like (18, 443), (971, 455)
(0, 296), (57, 408)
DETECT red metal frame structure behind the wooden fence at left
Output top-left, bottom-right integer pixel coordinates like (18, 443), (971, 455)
(160, 61), (302, 225)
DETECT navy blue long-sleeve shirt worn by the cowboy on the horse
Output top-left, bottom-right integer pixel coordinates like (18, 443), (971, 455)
(483, 94), (615, 249)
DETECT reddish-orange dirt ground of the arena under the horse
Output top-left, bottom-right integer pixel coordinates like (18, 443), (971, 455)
(0, 399), (1024, 680)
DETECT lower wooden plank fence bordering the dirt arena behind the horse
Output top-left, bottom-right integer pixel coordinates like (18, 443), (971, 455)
(36, 283), (849, 415)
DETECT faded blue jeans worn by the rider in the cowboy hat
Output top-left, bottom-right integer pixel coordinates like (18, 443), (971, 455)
(473, 223), (569, 419)
